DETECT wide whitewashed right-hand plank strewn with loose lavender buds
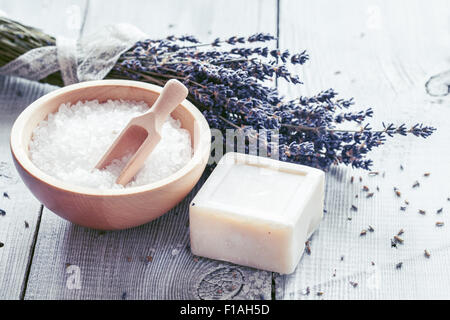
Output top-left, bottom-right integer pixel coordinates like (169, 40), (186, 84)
(275, 0), (450, 299)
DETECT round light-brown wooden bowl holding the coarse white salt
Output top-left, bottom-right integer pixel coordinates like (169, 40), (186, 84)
(11, 80), (211, 230)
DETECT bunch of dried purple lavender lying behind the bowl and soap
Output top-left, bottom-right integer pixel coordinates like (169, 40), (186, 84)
(0, 17), (435, 170)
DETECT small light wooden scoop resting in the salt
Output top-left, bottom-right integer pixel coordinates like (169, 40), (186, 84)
(96, 79), (188, 186)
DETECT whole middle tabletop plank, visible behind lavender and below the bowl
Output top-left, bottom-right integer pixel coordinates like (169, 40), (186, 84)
(25, 1), (276, 299)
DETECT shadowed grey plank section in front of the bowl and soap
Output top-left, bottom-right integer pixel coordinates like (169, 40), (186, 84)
(26, 180), (271, 299)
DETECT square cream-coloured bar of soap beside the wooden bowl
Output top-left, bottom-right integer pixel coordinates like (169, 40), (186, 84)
(189, 153), (325, 274)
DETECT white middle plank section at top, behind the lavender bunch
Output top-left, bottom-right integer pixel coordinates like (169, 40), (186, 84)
(83, 0), (277, 41)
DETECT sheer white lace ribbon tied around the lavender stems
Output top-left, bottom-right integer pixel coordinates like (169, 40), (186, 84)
(0, 24), (146, 85)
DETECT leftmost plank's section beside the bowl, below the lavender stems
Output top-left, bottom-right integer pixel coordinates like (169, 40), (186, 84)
(0, 77), (58, 299)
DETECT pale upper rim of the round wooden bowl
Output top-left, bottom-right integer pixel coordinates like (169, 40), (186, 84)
(10, 80), (211, 197)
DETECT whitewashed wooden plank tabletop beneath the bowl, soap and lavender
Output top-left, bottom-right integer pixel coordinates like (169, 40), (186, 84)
(0, 0), (450, 299)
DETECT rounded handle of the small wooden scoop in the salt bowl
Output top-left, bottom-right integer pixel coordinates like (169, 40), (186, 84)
(150, 79), (189, 131)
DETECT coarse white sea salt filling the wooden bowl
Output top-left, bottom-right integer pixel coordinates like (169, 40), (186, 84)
(29, 100), (192, 189)
